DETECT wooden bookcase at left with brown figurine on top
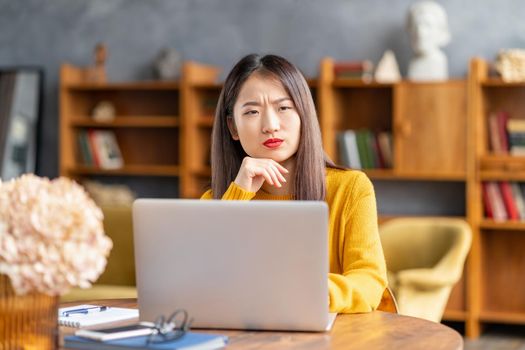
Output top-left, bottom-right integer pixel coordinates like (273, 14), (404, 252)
(60, 62), (214, 197)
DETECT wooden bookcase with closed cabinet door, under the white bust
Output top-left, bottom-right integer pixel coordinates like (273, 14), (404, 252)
(318, 58), (468, 328)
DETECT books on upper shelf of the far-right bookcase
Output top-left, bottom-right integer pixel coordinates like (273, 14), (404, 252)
(489, 112), (525, 156)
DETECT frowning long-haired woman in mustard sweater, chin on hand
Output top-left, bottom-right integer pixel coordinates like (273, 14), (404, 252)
(202, 54), (387, 313)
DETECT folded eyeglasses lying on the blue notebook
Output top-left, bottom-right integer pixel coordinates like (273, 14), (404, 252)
(147, 309), (193, 344)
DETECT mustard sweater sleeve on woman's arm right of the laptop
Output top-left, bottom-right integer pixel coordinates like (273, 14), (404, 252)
(328, 174), (387, 313)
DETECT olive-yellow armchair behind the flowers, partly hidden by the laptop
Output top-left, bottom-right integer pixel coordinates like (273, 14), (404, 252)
(61, 205), (137, 301)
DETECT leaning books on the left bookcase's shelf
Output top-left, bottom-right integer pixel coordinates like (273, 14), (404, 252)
(77, 129), (124, 169)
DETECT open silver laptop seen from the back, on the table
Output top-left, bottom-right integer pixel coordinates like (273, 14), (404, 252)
(133, 199), (335, 331)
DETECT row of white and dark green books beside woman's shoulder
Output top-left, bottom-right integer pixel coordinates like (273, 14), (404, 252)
(337, 129), (393, 169)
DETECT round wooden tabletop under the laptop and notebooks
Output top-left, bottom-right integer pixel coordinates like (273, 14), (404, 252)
(60, 299), (463, 350)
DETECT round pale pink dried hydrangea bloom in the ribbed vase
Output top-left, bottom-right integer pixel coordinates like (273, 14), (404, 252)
(0, 175), (112, 295)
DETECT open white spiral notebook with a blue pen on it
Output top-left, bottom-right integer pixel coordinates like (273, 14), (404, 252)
(58, 304), (139, 328)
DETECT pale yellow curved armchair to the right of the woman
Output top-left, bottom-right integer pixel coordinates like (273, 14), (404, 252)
(379, 218), (472, 322)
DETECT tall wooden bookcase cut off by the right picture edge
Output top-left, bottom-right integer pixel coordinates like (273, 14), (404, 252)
(466, 58), (525, 337)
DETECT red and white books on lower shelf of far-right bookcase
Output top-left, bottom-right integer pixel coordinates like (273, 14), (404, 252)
(482, 181), (525, 222)
